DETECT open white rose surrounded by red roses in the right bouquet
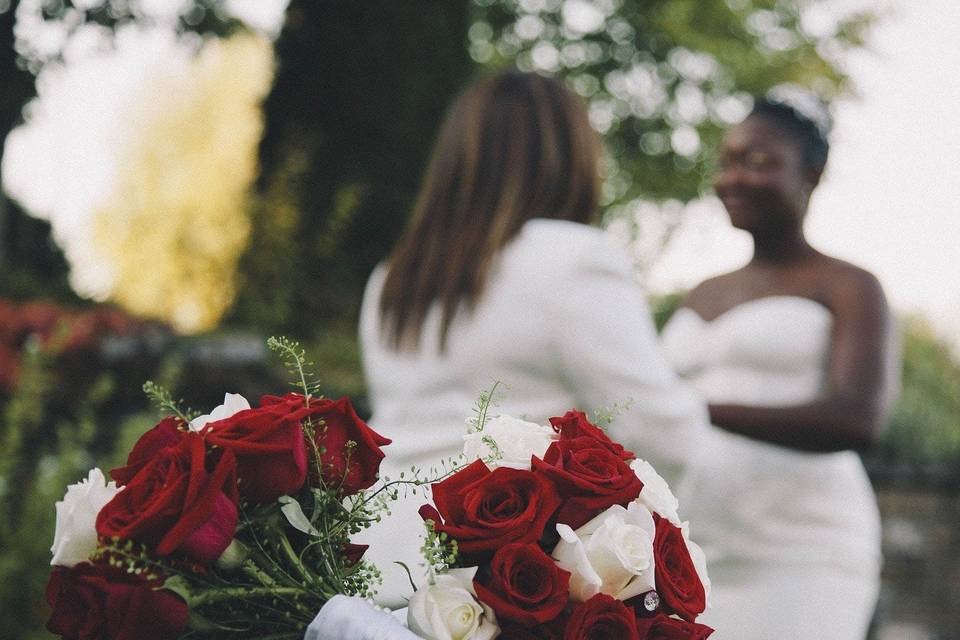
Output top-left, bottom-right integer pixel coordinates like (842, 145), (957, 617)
(553, 502), (656, 602)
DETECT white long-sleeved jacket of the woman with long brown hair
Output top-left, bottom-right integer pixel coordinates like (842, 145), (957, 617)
(355, 219), (708, 607)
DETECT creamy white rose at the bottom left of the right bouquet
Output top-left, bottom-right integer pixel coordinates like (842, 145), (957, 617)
(407, 567), (500, 640)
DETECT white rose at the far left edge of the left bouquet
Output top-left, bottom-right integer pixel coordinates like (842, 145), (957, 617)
(50, 469), (119, 567)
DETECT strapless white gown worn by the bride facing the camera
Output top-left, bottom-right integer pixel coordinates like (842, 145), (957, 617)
(663, 296), (881, 640)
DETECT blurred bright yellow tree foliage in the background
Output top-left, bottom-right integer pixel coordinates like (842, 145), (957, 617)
(94, 34), (273, 333)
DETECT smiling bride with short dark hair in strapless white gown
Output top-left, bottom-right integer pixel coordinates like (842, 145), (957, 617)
(663, 96), (898, 640)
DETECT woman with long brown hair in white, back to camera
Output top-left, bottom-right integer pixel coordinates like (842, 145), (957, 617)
(360, 71), (707, 605)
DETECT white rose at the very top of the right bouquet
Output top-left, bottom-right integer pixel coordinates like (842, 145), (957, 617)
(463, 414), (558, 469)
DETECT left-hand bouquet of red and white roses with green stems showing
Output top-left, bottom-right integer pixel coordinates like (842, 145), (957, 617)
(47, 339), (390, 640)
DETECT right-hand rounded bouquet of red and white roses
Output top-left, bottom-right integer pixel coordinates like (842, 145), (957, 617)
(407, 411), (713, 640)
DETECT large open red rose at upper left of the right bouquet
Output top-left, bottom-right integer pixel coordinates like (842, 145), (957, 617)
(420, 460), (560, 556)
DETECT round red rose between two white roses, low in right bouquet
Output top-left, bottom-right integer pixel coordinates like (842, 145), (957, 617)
(473, 543), (570, 627)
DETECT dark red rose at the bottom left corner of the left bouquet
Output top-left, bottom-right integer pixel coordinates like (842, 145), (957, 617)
(47, 562), (187, 640)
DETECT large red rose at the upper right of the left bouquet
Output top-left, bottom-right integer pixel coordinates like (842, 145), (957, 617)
(260, 393), (390, 495)
